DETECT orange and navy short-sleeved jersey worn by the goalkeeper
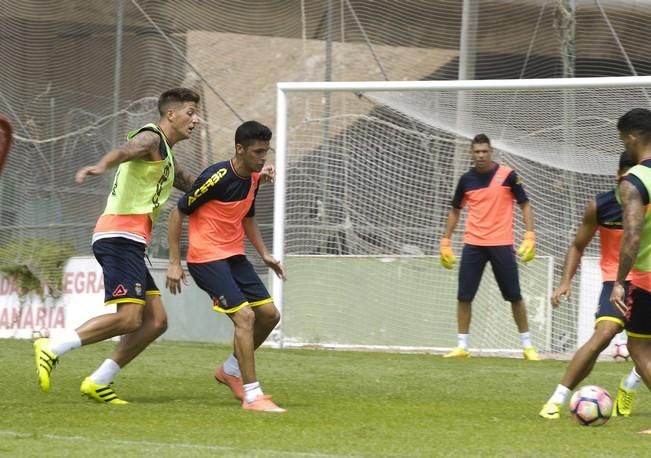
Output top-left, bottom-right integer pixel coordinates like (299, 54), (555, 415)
(452, 164), (529, 246)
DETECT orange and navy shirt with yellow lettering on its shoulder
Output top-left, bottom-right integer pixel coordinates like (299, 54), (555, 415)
(178, 161), (260, 263)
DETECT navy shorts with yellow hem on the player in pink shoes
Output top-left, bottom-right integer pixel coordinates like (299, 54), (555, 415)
(188, 255), (273, 313)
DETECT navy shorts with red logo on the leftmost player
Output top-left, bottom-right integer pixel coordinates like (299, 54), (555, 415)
(93, 237), (160, 305)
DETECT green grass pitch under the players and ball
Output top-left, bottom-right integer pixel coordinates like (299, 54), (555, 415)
(0, 340), (651, 458)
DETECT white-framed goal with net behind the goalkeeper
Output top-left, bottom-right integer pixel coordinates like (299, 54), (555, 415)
(273, 77), (651, 354)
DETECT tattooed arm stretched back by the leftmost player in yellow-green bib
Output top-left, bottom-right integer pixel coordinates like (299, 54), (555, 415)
(75, 131), (160, 183)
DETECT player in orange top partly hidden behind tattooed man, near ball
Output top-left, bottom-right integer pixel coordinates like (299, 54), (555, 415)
(539, 152), (640, 420)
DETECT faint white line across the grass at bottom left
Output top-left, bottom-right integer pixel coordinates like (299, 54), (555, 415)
(0, 430), (354, 458)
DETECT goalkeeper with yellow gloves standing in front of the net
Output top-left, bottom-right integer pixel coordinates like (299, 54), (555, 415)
(440, 134), (540, 361)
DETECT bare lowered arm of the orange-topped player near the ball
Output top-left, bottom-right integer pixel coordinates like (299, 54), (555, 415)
(551, 201), (598, 307)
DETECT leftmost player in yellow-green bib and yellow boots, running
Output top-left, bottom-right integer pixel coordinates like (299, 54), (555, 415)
(34, 88), (200, 404)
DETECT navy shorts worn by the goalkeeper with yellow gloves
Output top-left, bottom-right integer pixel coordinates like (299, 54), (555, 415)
(457, 244), (522, 302)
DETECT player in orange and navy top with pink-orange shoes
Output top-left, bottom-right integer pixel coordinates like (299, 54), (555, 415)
(167, 121), (285, 412)
